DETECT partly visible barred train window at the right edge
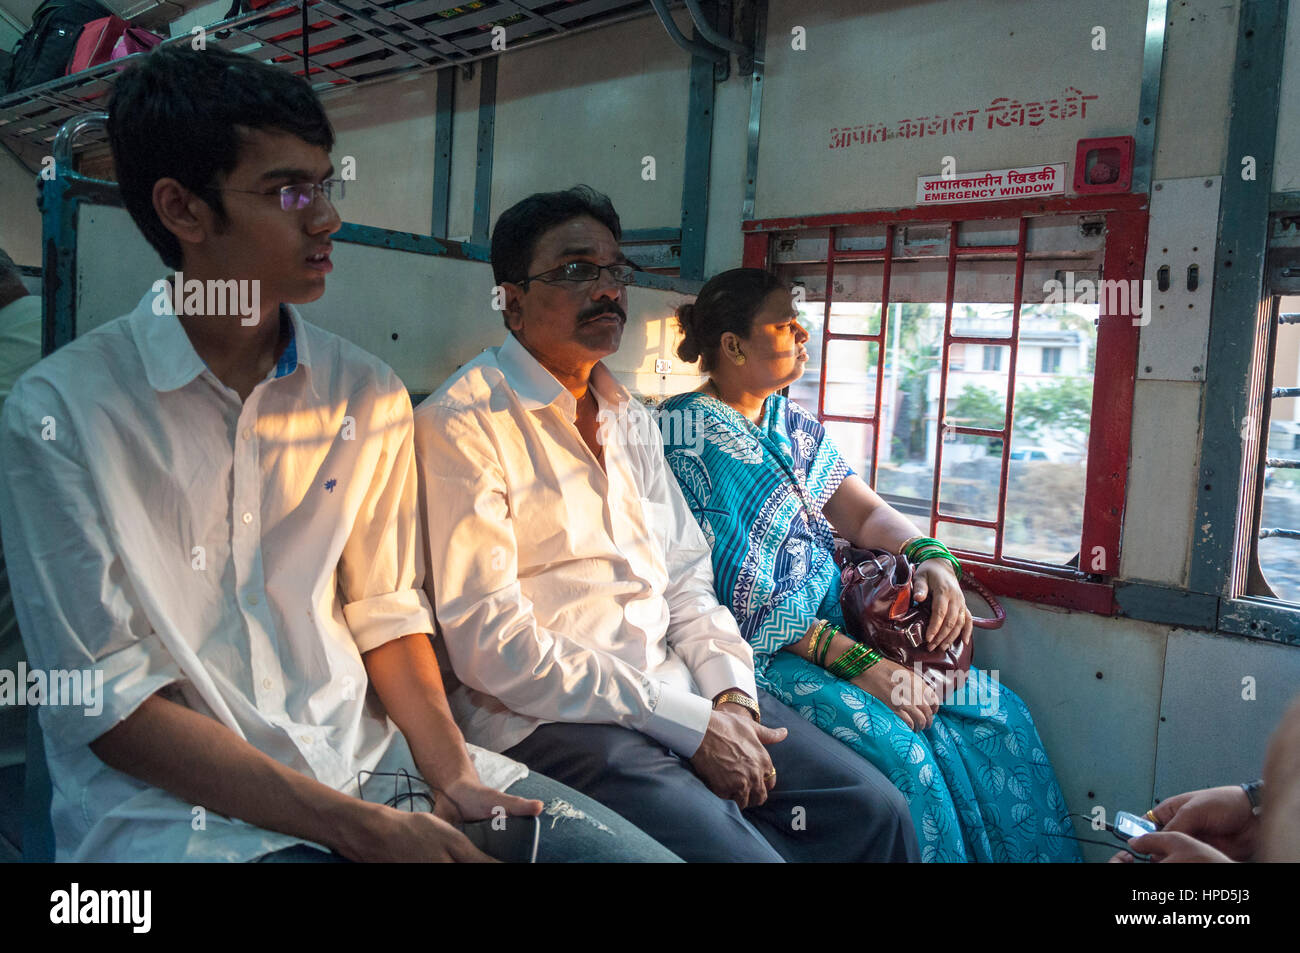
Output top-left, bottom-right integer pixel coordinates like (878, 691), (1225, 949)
(1247, 298), (1300, 602)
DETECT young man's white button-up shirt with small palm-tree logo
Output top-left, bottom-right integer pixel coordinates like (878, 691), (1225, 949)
(0, 294), (527, 861)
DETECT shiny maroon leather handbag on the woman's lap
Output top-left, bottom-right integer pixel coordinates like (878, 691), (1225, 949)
(835, 546), (1006, 698)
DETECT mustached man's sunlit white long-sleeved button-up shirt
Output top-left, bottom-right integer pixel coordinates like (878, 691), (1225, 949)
(415, 335), (755, 757)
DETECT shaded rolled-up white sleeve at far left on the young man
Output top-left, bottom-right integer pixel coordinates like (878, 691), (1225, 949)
(0, 378), (183, 750)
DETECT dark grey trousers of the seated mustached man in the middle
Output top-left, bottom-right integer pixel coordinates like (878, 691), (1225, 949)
(506, 690), (920, 863)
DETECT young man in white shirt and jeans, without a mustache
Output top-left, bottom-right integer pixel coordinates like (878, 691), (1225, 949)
(0, 48), (671, 861)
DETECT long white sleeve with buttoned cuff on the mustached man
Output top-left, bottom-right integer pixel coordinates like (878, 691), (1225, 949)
(416, 404), (711, 757)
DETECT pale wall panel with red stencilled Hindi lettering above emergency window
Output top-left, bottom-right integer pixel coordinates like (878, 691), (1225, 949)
(757, 0), (1147, 218)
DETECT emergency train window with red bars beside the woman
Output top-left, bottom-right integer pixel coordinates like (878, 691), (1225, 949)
(771, 206), (1139, 576)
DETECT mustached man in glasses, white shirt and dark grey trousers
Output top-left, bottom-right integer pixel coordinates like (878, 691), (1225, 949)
(416, 187), (917, 861)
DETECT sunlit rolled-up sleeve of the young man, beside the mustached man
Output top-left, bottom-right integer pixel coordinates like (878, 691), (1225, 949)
(339, 376), (433, 653)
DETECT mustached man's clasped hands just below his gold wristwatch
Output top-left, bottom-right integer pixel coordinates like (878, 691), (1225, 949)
(690, 702), (787, 810)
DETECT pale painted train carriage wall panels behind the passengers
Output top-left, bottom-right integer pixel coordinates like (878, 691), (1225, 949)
(0, 0), (1300, 859)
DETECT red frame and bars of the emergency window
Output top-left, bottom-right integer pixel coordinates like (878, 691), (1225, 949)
(742, 195), (1148, 615)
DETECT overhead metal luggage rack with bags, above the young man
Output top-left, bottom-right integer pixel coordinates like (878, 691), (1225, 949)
(0, 0), (653, 148)
